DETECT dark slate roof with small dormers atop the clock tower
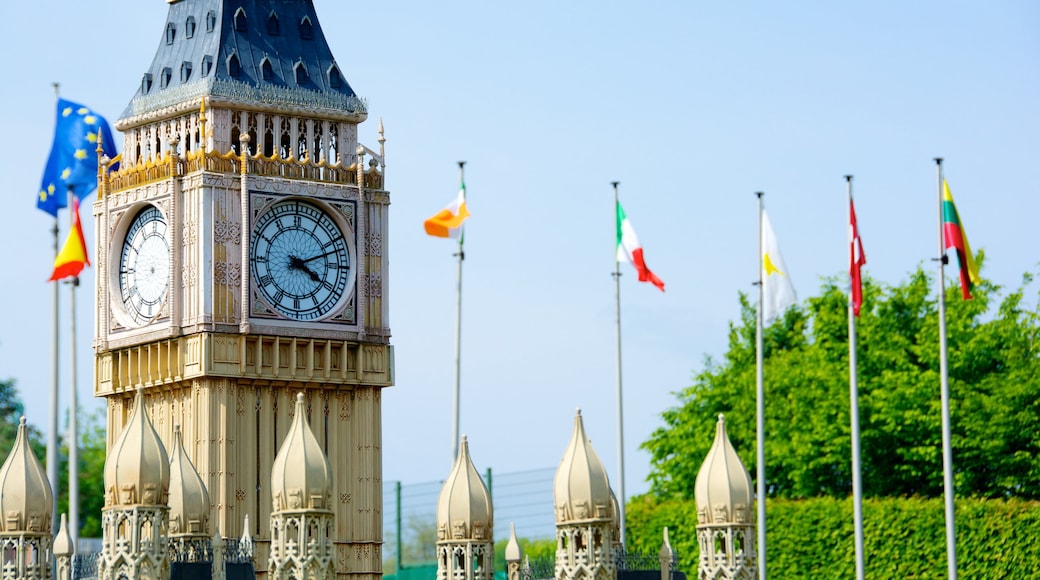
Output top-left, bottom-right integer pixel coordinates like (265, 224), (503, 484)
(122, 0), (365, 118)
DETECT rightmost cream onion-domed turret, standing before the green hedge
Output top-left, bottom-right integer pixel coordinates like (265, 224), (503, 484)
(694, 415), (758, 580)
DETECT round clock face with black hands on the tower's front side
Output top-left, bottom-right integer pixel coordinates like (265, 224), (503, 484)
(250, 200), (350, 320)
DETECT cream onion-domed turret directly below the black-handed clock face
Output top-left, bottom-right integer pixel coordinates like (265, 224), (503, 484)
(267, 393), (336, 580)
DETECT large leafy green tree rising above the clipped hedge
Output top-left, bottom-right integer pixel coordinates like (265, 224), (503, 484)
(643, 261), (1040, 499)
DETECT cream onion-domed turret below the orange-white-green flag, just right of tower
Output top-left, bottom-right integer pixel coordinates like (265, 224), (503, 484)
(437, 437), (495, 580)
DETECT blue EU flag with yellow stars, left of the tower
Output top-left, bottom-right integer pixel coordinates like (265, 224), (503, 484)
(36, 99), (115, 217)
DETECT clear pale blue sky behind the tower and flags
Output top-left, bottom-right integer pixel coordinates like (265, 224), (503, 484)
(0, 0), (1040, 530)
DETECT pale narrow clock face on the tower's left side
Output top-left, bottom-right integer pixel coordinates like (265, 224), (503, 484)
(120, 206), (170, 324)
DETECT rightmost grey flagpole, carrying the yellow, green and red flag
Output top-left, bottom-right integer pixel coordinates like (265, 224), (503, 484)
(935, 157), (957, 580)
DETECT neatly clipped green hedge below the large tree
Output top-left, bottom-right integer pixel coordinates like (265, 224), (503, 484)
(626, 496), (1040, 580)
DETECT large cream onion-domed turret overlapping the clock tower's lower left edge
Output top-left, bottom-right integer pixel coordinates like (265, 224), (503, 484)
(98, 391), (170, 580)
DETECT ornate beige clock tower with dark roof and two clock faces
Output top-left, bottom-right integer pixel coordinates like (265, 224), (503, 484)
(94, 0), (393, 580)
